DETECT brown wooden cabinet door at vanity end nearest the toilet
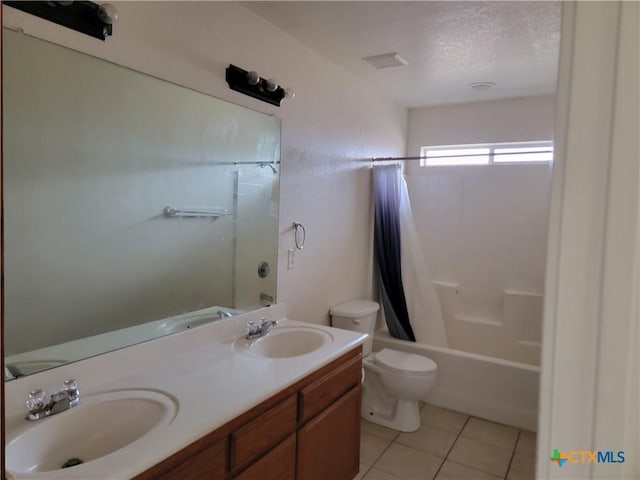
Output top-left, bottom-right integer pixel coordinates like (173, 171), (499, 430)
(296, 385), (361, 480)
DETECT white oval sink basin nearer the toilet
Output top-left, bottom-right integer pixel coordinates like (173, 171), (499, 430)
(236, 326), (334, 358)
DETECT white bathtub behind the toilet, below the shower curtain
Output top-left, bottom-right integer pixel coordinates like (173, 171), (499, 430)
(373, 331), (540, 431)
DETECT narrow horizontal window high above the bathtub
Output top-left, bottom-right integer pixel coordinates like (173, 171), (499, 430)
(420, 142), (553, 167)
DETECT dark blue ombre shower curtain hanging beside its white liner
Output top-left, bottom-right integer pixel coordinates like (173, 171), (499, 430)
(373, 166), (416, 342)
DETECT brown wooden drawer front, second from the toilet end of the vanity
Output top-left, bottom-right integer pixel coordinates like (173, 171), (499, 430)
(231, 395), (297, 471)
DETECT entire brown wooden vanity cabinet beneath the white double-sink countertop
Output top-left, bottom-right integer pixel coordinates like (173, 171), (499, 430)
(135, 347), (362, 480)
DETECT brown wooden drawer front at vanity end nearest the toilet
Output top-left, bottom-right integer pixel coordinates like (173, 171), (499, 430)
(298, 348), (362, 422)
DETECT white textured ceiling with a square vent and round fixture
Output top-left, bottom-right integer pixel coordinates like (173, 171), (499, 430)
(242, 1), (560, 108)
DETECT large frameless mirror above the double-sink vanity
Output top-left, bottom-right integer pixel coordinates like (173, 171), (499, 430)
(2, 29), (280, 379)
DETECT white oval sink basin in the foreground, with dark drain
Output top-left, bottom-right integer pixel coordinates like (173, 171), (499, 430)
(5, 390), (177, 478)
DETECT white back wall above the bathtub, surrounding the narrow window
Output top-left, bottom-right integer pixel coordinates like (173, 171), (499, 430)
(406, 96), (554, 365)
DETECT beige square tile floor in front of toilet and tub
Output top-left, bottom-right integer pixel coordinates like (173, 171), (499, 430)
(354, 405), (536, 480)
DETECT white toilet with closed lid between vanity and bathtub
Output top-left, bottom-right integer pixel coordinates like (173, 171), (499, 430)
(330, 300), (438, 432)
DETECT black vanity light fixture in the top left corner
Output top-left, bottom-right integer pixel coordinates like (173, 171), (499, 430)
(2, 0), (118, 40)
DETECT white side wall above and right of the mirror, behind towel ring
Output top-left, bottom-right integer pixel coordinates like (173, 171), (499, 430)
(2, 2), (406, 330)
